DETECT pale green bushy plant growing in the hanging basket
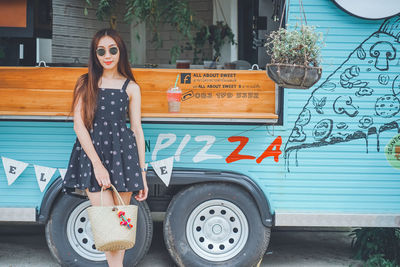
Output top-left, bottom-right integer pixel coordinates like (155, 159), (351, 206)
(265, 24), (323, 67)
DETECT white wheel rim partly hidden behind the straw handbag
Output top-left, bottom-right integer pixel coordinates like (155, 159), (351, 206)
(67, 201), (106, 261)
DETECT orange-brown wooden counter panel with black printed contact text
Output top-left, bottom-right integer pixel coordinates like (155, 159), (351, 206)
(0, 67), (278, 122)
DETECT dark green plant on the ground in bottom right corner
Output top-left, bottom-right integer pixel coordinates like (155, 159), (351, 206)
(350, 228), (400, 266)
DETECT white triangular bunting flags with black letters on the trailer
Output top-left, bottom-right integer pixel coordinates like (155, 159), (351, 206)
(1, 156), (174, 192)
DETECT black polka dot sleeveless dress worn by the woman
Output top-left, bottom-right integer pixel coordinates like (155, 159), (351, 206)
(63, 79), (144, 194)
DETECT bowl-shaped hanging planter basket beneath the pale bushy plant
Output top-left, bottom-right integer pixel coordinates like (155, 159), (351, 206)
(267, 64), (322, 89)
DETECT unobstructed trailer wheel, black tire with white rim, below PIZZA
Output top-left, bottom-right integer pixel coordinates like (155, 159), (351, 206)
(164, 183), (271, 267)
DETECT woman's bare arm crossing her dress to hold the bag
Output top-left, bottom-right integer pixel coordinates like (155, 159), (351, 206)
(74, 98), (111, 188)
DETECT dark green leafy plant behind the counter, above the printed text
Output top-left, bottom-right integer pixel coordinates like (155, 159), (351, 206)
(193, 21), (236, 64)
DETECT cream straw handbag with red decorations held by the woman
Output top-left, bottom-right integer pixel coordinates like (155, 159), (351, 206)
(87, 185), (138, 251)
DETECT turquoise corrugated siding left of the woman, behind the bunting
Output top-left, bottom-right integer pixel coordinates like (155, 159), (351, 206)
(0, 121), (75, 207)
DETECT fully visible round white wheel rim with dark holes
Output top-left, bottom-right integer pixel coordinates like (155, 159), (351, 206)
(186, 199), (249, 262)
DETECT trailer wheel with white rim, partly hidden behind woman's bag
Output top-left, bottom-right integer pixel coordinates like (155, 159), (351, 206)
(45, 194), (153, 267)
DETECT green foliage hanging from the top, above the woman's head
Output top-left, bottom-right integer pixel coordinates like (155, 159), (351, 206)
(85, 0), (201, 63)
